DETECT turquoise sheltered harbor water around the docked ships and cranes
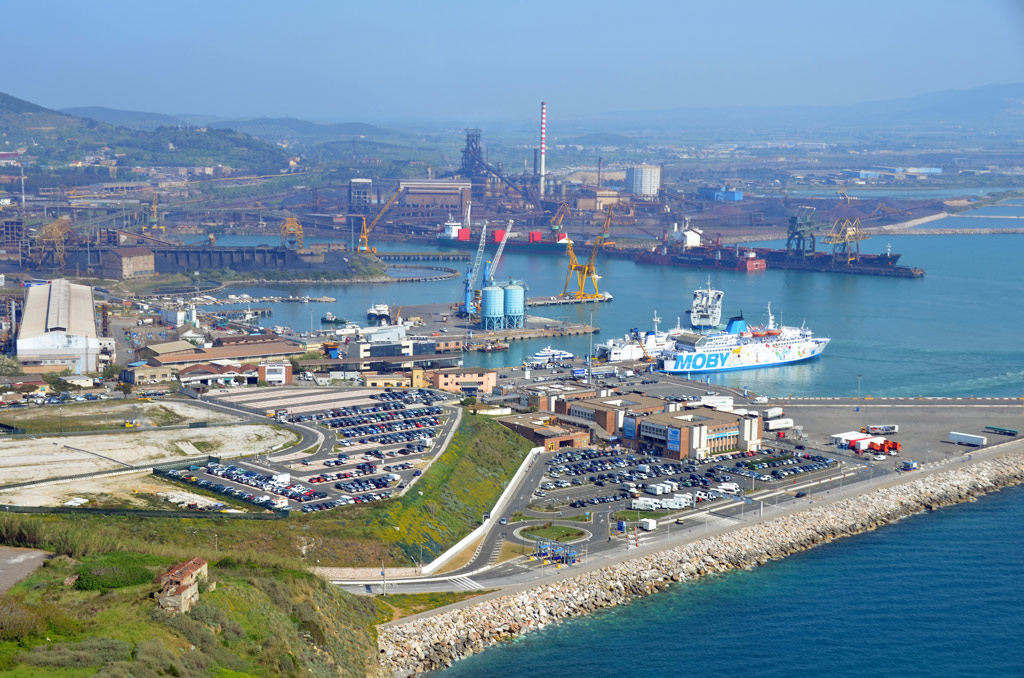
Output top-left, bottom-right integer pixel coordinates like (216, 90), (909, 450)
(203, 225), (1024, 396)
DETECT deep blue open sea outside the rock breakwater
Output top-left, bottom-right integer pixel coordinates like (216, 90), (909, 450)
(440, 488), (1024, 678)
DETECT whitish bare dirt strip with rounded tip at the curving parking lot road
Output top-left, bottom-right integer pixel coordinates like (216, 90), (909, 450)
(0, 424), (298, 485)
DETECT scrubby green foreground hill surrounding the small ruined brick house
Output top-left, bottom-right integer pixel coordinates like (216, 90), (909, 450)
(0, 553), (386, 678)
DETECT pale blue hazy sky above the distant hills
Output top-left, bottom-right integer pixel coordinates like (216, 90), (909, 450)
(8, 0), (1024, 123)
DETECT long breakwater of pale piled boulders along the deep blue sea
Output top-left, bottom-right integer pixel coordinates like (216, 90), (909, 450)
(378, 446), (1024, 677)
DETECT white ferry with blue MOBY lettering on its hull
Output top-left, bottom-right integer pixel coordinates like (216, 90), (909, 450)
(663, 306), (828, 374)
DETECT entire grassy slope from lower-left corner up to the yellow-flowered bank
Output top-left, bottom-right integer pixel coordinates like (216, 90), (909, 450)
(0, 416), (529, 677)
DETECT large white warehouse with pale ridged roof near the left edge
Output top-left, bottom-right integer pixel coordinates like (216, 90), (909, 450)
(17, 280), (99, 374)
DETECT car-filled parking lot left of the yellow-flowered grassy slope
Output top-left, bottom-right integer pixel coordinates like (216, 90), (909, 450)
(168, 388), (454, 513)
